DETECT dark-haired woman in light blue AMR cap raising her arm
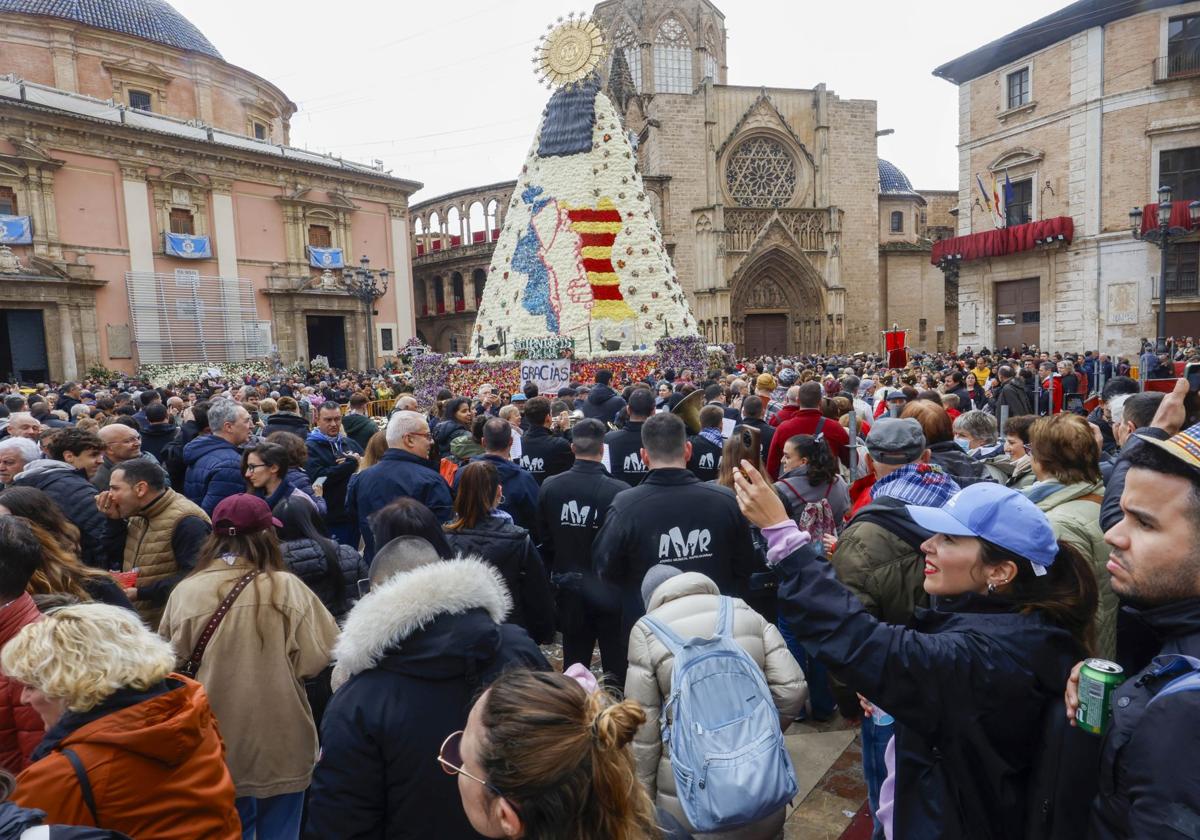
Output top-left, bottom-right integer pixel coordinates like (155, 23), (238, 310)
(736, 470), (1097, 840)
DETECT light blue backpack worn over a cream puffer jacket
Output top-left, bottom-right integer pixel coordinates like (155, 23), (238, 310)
(641, 598), (798, 832)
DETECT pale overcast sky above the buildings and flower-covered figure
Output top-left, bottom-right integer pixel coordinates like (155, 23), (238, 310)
(172, 0), (1066, 200)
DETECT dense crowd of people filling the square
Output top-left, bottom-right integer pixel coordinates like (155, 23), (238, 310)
(0, 340), (1200, 840)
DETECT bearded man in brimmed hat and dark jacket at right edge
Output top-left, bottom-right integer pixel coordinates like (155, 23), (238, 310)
(1067, 379), (1200, 840)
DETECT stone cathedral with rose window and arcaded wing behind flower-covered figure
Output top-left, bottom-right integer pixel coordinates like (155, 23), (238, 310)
(412, 0), (956, 355)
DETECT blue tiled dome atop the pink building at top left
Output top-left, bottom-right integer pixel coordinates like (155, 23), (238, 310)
(0, 0), (221, 59)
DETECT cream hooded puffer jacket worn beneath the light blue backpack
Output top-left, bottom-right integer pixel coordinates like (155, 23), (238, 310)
(625, 571), (809, 836)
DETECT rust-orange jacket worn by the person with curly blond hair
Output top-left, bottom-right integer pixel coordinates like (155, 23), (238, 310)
(12, 674), (241, 840)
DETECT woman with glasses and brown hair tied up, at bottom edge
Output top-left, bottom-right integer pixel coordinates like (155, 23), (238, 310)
(438, 666), (688, 840)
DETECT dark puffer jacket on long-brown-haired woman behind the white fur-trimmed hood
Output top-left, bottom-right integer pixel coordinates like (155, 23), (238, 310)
(446, 515), (554, 644)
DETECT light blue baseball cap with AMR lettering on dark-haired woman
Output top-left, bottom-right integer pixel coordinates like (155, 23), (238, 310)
(907, 481), (1058, 576)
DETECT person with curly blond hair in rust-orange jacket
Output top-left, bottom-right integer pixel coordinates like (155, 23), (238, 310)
(0, 604), (241, 840)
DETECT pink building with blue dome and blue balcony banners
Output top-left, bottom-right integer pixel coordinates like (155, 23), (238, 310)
(0, 0), (420, 382)
